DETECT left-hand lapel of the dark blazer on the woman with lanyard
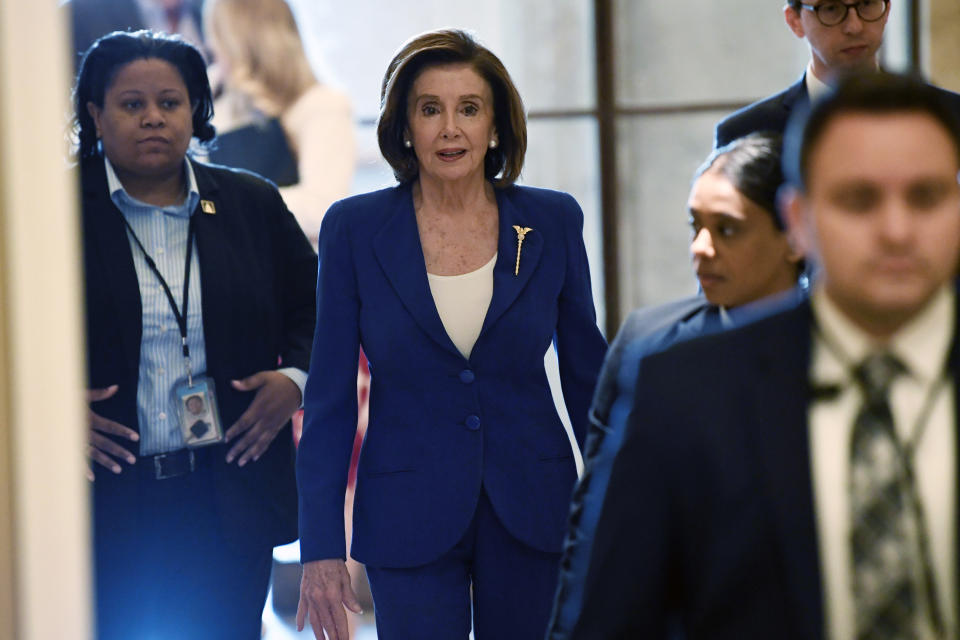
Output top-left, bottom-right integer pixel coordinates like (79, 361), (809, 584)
(83, 158), (143, 374)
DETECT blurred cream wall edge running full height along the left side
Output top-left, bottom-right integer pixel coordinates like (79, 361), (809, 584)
(0, 0), (92, 640)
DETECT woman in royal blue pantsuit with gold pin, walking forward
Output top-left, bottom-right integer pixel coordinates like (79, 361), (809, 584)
(297, 31), (606, 640)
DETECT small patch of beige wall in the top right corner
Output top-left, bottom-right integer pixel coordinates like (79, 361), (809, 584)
(921, 0), (960, 91)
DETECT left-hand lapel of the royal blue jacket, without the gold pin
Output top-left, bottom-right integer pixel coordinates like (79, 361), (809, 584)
(373, 186), (462, 358)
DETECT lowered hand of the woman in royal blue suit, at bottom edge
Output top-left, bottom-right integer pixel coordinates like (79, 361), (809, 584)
(297, 558), (363, 640)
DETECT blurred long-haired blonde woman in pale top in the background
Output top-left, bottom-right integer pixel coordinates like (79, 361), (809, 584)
(203, 0), (355, 248)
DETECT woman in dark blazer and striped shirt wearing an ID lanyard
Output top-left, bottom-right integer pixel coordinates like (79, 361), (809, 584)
(74, 31), (317, 639)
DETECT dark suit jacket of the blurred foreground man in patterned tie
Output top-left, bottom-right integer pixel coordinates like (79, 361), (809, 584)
(564, 302), (960, 640)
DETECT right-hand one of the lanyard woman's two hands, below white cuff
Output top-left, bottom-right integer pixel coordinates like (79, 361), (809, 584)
(224, 371), (300, 467)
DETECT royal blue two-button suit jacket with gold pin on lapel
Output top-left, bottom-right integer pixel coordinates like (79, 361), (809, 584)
(297, 184), (606, 567)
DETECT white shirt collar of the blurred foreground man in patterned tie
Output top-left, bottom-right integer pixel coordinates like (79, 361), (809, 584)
(811, 284), (956, 384)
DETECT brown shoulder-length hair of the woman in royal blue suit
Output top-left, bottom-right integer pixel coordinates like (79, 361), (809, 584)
(377, 29), (527, 187)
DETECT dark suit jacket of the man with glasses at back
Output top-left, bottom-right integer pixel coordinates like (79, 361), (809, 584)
(713, 72), (960, 149)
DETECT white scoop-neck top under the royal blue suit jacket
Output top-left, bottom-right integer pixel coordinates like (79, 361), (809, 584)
(427, 253), (497, 358)
